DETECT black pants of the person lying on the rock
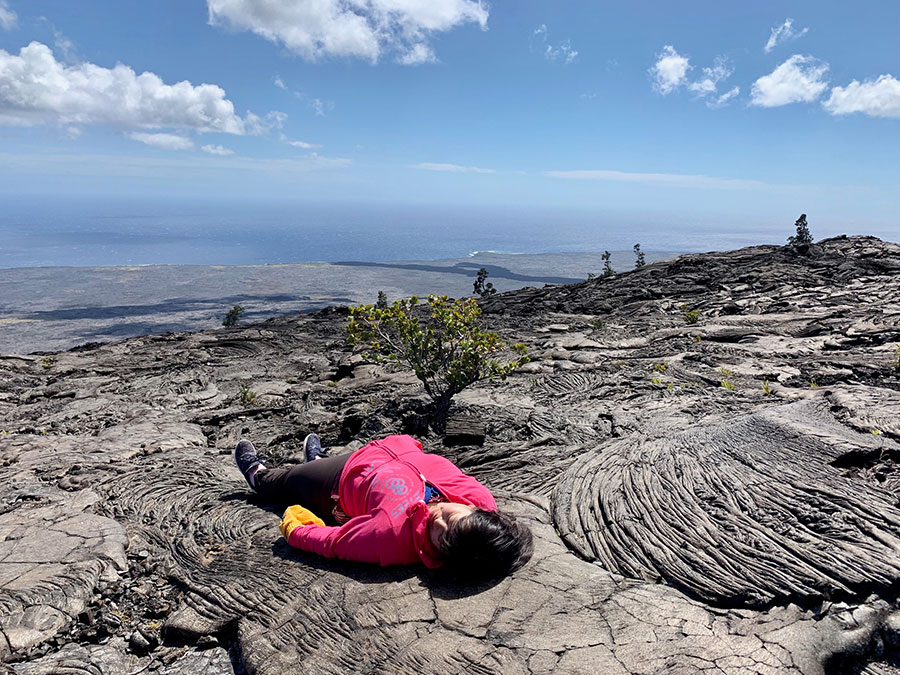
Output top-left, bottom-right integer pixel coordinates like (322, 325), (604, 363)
(253, 455), (350, 521)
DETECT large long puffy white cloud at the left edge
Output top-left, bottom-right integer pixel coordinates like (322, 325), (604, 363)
(0, 42), (270, 134)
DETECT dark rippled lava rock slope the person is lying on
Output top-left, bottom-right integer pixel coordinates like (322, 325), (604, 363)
(0, 237), (900, 675)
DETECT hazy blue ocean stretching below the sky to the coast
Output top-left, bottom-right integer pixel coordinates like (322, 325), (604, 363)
(0, 197), (790, 268)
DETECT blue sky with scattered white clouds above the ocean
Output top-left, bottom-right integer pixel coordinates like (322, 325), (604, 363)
(0, 0), (900, 240)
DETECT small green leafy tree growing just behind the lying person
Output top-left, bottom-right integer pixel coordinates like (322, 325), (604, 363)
(347, 295), (528, 430)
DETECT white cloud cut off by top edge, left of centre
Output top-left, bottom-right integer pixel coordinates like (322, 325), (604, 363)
(206, 0), (488, 63)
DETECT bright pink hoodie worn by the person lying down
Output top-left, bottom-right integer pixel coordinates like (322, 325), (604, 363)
(288, 436), (497, 569)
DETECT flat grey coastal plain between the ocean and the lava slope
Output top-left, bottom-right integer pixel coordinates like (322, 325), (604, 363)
(0, 251), (679, 354)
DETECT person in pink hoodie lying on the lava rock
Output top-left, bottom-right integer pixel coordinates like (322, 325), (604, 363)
(234, 434), (533, 580)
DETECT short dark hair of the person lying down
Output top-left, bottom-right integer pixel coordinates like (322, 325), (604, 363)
(441, 509), (534, 579)
